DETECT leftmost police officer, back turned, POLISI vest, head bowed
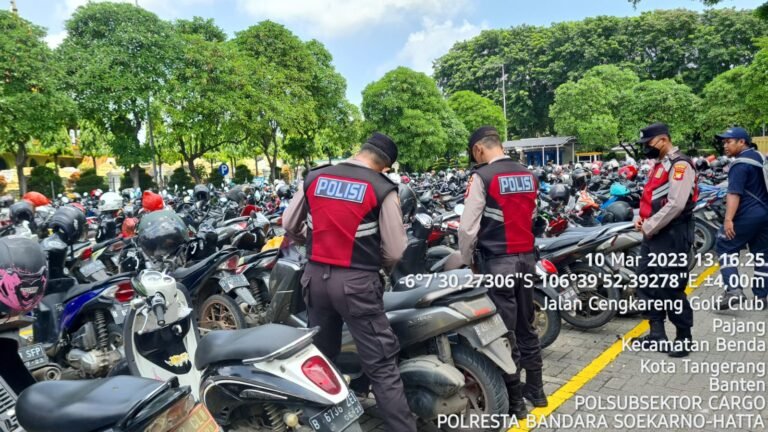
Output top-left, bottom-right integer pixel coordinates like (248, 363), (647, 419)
(283, 133), (416, 431)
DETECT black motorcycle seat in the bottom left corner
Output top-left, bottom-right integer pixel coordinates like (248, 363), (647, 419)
(16, 376), (165, 432)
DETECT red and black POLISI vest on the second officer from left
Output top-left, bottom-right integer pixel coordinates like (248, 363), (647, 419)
(473, 158), (538, 256)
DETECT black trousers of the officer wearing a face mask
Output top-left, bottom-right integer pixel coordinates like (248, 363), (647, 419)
(637, 220), (693, 333)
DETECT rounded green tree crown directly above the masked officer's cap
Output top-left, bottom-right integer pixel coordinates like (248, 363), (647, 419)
(618, 79), (701, 148)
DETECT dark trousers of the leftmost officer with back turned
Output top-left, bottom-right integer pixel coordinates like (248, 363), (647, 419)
(301, 262), (416, 432)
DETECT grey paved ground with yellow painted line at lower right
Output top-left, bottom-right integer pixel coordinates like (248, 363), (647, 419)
(362, 256), (768, 431)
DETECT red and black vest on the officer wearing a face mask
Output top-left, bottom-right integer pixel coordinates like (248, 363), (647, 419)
(640, 154), (699, 221)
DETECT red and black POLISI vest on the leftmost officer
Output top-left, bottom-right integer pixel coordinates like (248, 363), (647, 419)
(304, 162), (397, 271)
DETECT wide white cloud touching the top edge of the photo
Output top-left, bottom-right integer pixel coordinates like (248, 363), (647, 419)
(238, 0), (468, 37)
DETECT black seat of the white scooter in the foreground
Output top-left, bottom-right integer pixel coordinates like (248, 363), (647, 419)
(195, 324), (312, 370)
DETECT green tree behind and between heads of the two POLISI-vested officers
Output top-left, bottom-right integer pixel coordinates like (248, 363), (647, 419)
(362, 67), (468, 169)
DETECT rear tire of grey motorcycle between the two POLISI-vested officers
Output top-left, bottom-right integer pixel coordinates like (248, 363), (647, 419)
(451, 344), (509, 422)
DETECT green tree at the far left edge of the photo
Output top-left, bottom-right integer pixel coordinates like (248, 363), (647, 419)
(0, 11), (72, 193)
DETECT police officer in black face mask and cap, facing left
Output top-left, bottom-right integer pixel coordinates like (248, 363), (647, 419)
(635, 123), (698, 357)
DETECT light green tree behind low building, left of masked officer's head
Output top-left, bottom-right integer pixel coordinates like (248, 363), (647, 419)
(550, 65), (640, 150)
